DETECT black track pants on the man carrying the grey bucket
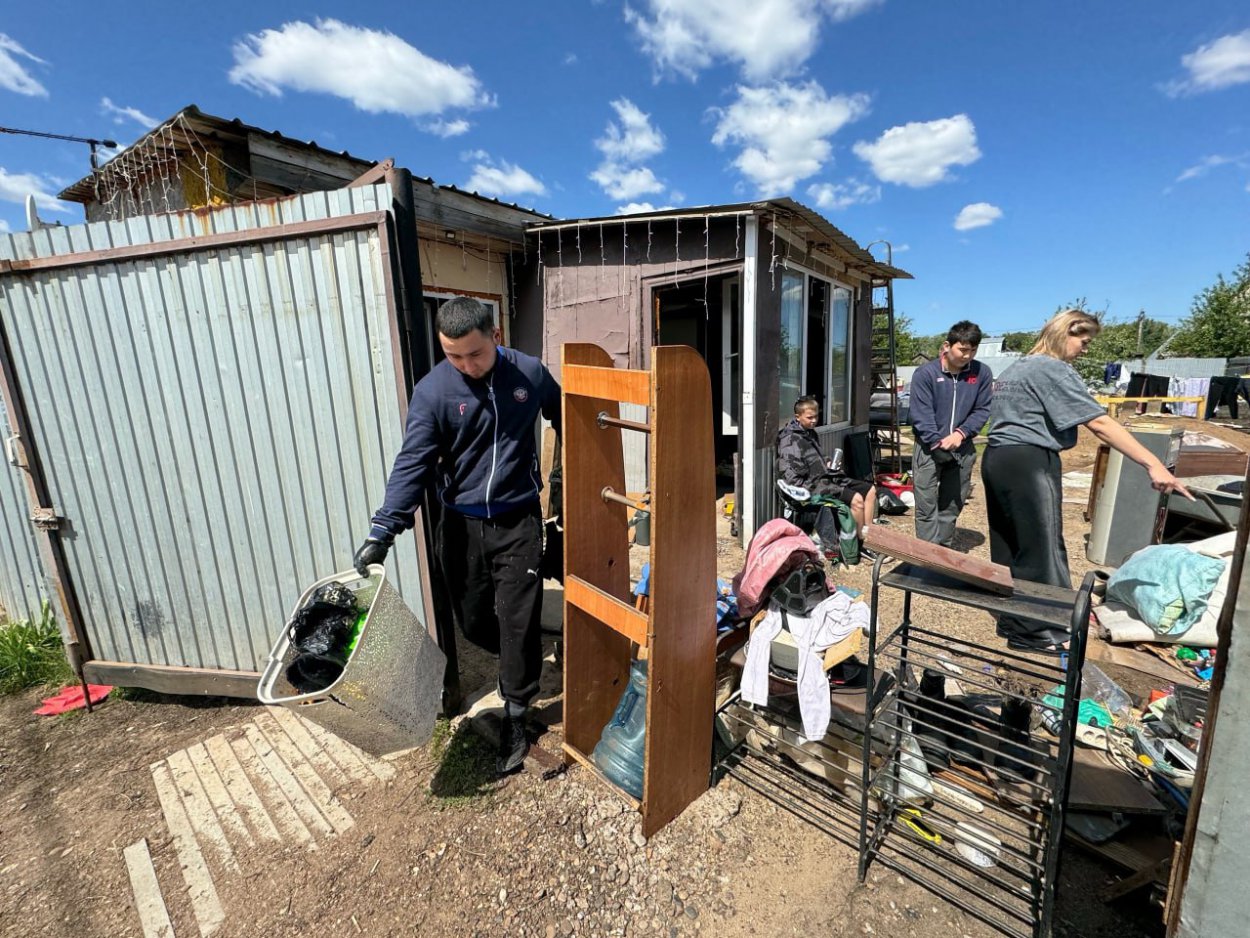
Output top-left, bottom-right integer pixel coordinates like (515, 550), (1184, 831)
(439, 503), (543, 705)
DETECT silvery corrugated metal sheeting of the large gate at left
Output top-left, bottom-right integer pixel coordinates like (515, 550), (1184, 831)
(0, 186), (424, 670)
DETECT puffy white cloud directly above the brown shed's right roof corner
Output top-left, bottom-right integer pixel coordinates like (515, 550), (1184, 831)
(711, 81), (869, 198)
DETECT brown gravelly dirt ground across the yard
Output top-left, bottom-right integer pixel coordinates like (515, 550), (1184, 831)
(0, 421), (1250, 938)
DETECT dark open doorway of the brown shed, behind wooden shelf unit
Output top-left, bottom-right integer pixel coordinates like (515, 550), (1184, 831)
(651, 273), (743, 487)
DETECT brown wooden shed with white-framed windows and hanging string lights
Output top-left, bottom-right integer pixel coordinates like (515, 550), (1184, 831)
(514, 205), (910, 539)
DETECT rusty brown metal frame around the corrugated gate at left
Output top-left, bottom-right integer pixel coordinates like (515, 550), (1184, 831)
(0, 210), (435, 710)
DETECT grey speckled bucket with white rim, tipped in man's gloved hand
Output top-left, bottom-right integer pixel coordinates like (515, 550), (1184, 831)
(256, 564), (446, 755)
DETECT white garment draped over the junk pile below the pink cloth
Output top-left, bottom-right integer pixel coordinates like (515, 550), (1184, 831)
(743, 593), (870, 742)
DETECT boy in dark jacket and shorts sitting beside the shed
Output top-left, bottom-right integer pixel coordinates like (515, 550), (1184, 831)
(778, 396), (876, 560)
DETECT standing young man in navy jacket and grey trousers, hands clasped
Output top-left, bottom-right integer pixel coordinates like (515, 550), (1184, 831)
(911, 319), (994, 547)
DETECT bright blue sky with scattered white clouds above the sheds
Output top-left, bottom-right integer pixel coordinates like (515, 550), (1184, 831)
(0, 0), (1250, 331)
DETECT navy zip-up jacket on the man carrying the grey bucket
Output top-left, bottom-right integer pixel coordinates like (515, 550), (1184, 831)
(370, 346), (560, 539)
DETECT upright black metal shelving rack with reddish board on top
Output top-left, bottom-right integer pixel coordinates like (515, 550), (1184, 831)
(860, 562), (1095, 938)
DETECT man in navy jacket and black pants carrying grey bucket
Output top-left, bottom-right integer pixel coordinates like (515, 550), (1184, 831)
(355, 296), (560, 773)
